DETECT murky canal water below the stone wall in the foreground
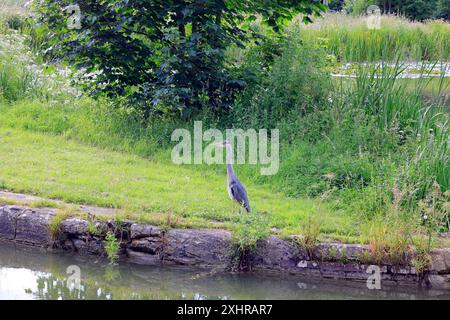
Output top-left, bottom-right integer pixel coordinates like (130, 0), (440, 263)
(0, 242), (450, 300)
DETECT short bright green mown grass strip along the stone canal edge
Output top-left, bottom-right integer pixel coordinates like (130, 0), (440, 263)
(0, 127), (357, 237)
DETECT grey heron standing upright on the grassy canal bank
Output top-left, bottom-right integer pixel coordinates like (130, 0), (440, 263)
(218, 140), (251, 213)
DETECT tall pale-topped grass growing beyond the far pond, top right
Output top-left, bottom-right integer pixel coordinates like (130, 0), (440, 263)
(302, 13), (450, 62)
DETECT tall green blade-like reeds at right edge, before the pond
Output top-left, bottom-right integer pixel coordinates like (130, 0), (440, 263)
(341, 62), (450, 204)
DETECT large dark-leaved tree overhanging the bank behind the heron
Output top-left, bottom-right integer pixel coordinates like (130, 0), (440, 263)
(35, 0), (326, 118)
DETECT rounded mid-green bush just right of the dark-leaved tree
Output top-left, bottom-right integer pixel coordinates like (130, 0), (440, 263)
(233, 29), (330, 129)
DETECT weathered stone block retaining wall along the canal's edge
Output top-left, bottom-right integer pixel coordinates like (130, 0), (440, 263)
(0, 206), (450, 291)
